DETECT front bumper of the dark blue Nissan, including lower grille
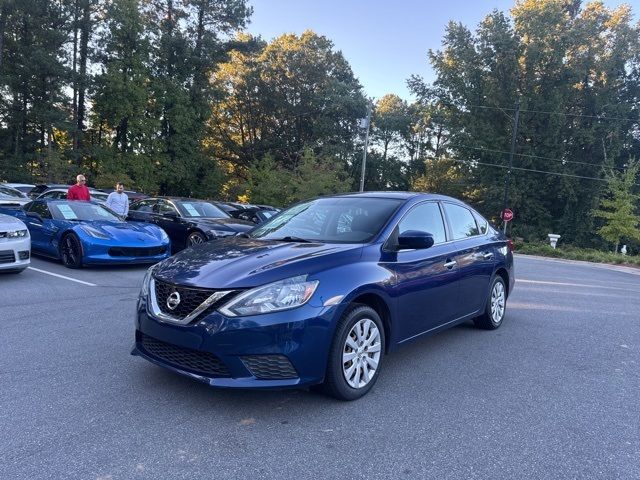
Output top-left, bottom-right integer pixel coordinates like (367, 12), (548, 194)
(131, 299), (336, 388)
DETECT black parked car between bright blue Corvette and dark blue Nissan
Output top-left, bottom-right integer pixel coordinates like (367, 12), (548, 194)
(127, 197), (255, 252)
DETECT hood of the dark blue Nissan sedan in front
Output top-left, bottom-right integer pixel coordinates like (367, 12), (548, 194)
(154, 237), (362, 288)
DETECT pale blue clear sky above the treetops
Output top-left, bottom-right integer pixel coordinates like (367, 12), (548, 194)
(247, 0), (640, 100)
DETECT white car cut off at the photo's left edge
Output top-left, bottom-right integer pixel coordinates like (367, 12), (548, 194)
(0, 214), (31, 273)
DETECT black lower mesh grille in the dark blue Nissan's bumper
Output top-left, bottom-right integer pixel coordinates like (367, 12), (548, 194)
(140, 333), (231, 378)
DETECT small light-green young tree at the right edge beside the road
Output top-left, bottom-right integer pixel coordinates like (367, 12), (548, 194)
(593, 160), (640, 253)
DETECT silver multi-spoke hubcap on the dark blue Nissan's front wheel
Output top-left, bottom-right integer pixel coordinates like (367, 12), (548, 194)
(342, 318), (382, 388)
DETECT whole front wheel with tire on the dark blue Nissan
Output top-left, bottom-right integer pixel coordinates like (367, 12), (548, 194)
(322, 305), (385, 400)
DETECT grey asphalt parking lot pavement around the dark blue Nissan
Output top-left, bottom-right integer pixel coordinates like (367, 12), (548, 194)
(0, 256), (640, 479)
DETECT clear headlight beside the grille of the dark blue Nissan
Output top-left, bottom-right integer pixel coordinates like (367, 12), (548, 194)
(220, 275), (320, 317)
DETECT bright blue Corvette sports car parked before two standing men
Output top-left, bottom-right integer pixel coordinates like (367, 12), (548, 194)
(5, 200), (171, 268)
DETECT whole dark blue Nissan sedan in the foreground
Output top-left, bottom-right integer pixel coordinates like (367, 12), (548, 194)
(132, 192), (515, 400)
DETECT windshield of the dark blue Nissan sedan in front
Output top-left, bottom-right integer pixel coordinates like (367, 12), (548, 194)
(250, 197), (403, 243)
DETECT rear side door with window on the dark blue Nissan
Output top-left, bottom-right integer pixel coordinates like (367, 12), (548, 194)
(442, 202), (495, 317)
